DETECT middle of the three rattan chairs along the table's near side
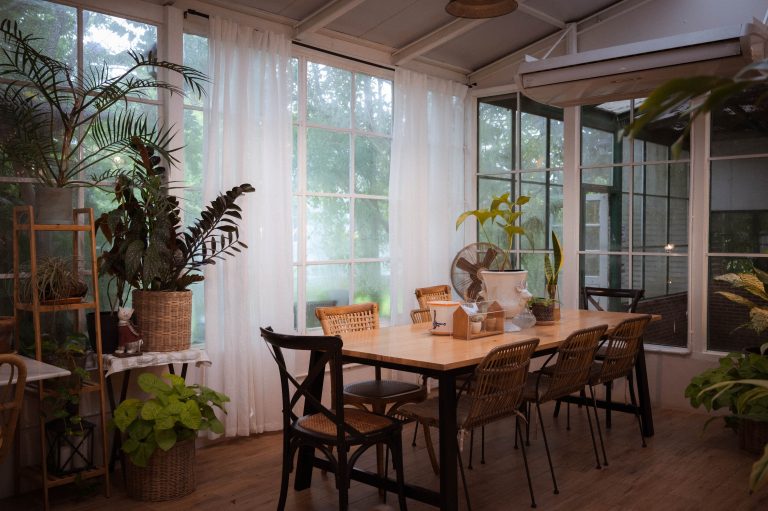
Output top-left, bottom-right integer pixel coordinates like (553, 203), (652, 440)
(515, 325), (608, 493)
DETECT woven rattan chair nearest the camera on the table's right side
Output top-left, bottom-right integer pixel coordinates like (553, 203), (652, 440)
(400, 339), (539, 510)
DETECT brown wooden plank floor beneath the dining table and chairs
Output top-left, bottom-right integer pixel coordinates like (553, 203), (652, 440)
(6, 407), (768, 511)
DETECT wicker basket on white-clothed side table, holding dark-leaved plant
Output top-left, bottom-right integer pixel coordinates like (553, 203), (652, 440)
(133, 290), (192, 351)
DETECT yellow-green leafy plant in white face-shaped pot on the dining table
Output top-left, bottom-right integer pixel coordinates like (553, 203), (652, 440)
(456, 192), (531, 318)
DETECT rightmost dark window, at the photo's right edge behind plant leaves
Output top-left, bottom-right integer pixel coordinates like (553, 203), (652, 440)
(707, 87), (768, 351)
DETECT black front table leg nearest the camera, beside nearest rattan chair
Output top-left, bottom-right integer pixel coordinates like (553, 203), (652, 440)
(438, 373), (459, 511)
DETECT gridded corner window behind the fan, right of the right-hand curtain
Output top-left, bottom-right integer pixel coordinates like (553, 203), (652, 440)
(477, 94), (563, 296)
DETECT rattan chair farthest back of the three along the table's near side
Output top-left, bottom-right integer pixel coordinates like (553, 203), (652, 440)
(588, 315), (651, 465)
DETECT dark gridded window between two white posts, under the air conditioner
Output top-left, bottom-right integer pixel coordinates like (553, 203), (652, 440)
(579, 100), (689, 347)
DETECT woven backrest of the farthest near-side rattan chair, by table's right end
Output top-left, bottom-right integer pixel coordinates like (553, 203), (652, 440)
(598, 315), (651, 383)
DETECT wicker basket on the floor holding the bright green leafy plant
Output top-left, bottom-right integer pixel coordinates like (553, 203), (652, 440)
(123, 438), (195, 502)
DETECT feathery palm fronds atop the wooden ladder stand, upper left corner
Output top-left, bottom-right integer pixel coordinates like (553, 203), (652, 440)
(0, 19), (207, 187)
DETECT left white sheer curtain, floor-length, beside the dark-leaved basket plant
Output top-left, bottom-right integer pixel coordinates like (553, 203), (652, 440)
(204, 17), (293, 436)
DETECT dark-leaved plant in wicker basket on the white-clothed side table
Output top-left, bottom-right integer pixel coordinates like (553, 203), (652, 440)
(96, 137), (254, 351)
